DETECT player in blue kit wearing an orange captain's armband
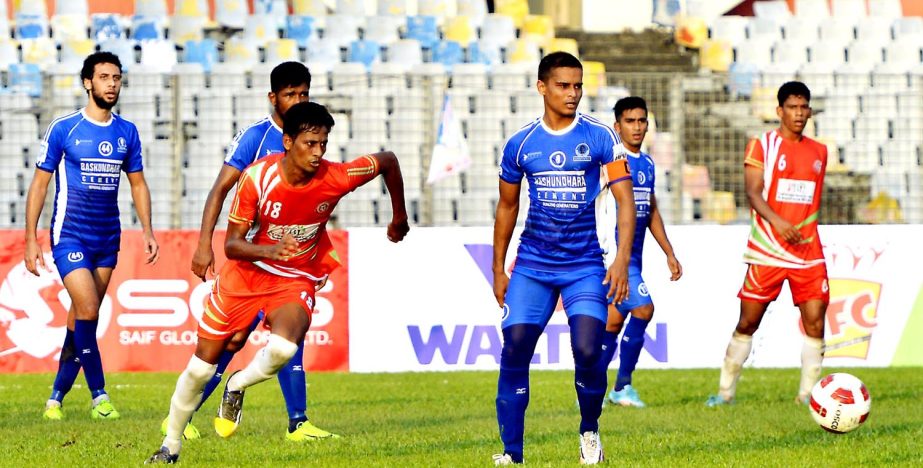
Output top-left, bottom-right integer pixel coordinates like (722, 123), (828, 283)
(493, 52), (635, 465)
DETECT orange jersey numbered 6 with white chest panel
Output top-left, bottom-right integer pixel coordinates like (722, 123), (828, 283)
(744, 130), (827, 268)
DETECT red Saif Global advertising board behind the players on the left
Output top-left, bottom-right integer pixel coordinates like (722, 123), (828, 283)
(0, 230), (349, 373)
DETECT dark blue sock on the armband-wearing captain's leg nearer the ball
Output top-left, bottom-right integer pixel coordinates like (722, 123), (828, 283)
(570, 315), (606, 434)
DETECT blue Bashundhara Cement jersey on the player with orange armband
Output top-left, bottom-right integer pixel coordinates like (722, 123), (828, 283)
(500, 113), (628, 271)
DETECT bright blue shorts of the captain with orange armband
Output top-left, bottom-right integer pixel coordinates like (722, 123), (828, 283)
(501, 267), (607, 328)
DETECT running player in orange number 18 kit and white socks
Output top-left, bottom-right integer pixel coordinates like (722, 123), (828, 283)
(148, 102), (409, 463)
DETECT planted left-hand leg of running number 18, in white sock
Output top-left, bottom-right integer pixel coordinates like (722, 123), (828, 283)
(148, 331), (227, 463)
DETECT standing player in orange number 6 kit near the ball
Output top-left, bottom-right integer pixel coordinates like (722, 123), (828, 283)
(706, 81), (830, 406)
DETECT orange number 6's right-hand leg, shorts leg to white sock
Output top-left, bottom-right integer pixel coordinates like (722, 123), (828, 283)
(789, 264), (830, 403)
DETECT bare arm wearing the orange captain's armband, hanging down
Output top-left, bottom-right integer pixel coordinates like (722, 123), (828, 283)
(603, 176), (637, 304)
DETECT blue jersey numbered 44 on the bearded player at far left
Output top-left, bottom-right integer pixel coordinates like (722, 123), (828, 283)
(35, 110), (143, 250)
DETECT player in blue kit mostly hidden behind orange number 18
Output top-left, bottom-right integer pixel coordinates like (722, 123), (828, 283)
(161, 62), (336, 442)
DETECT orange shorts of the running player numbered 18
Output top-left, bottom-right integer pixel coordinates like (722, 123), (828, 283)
(199, 260), (316, 340)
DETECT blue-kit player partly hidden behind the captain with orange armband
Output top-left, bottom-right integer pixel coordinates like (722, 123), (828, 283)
(602, 96), (683, 408)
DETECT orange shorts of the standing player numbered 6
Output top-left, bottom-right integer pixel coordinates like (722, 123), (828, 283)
(737, 263), (830, 305)
